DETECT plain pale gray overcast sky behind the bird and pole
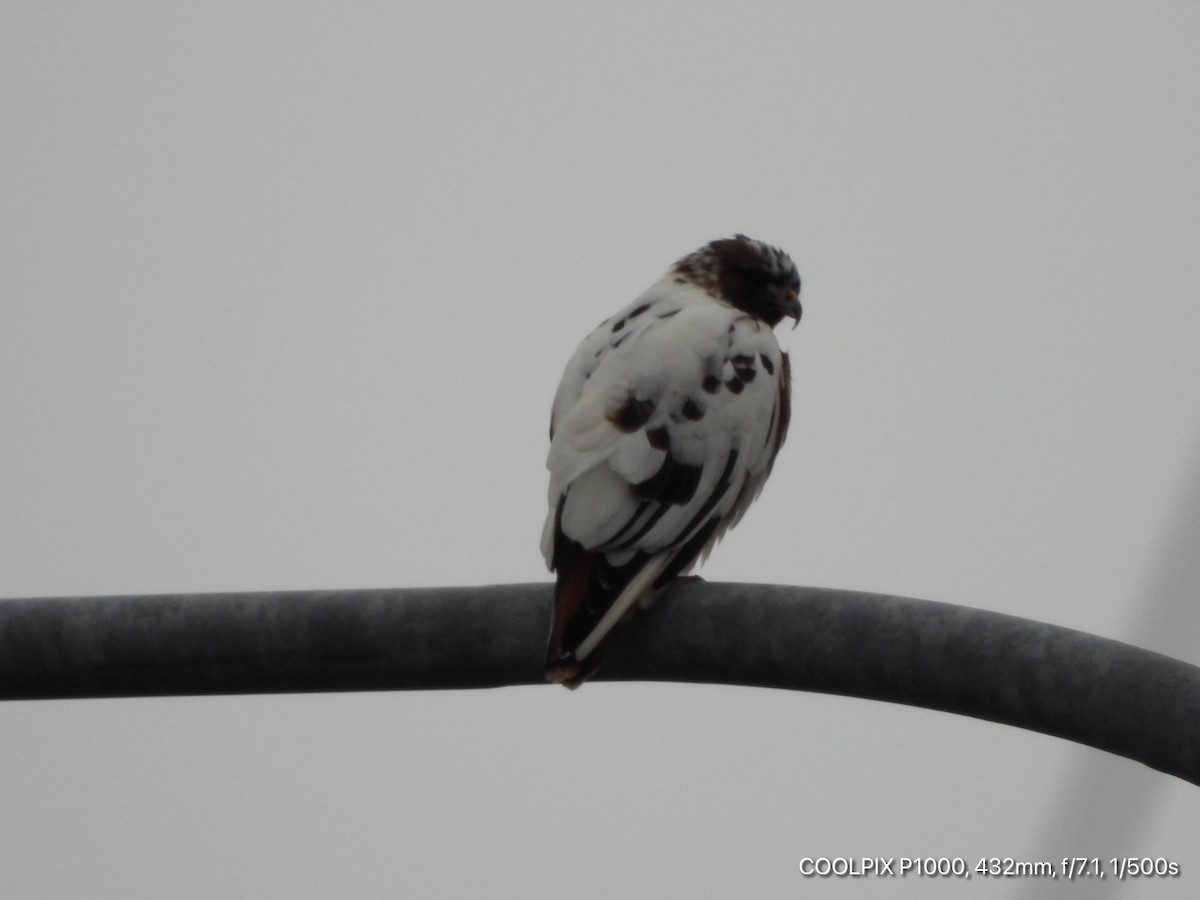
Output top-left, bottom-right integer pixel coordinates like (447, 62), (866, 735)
(0, 2), (1200, 900)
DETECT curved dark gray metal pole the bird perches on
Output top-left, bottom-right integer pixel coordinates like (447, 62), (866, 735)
(0, 581), (1200, 784)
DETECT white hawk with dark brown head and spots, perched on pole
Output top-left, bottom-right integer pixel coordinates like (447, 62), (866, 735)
(541, 234), (802, 689)
